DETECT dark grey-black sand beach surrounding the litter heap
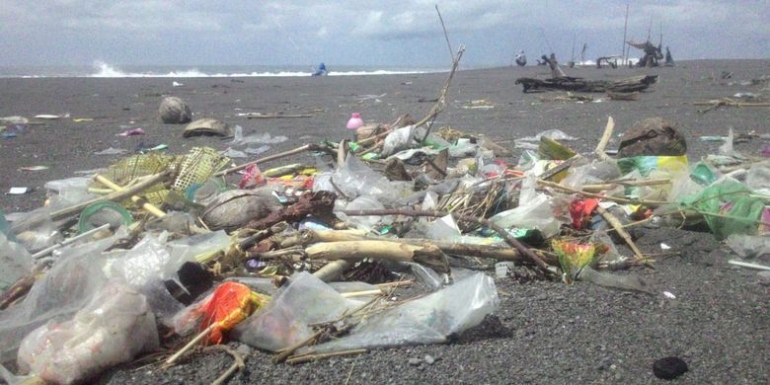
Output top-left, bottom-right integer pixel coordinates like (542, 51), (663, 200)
(0, 60), (770, 384)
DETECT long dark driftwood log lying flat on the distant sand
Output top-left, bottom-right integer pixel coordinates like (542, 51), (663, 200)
(515, 75), (658, 93)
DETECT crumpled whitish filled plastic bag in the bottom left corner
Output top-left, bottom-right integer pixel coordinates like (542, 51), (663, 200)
(18, 283), (159, 384)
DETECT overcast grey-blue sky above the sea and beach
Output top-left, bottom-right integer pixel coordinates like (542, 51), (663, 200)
(0, 0), (770, 68)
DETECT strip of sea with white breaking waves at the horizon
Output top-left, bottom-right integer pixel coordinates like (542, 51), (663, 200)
(0, 62), (449, 78)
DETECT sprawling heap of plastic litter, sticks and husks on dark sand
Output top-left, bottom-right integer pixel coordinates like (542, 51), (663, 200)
(0, 112), (770, 383)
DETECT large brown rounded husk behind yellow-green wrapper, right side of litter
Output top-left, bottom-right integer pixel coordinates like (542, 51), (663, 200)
(618, 118), (687, 158)
